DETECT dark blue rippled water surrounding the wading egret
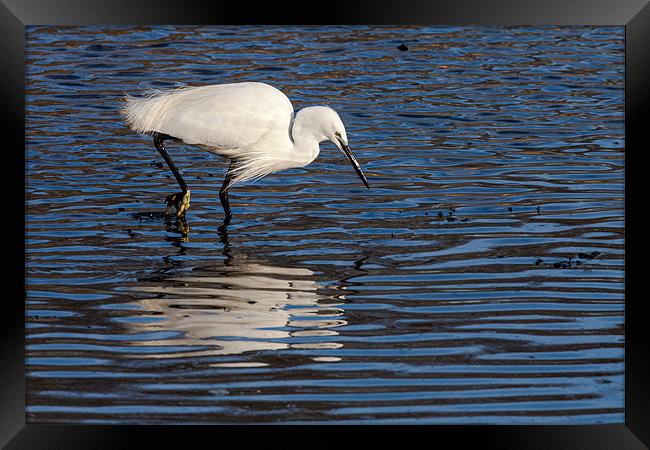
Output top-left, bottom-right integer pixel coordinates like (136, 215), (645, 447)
(26, 26), (624, 424)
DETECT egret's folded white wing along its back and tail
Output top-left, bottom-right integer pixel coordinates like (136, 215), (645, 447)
(124, 83), (293, 150)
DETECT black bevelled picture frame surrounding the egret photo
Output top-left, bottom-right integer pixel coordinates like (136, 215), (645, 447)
(0, 0), (650, 450)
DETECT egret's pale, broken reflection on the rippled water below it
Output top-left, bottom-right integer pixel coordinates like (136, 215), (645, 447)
(122, 235), (346, 365)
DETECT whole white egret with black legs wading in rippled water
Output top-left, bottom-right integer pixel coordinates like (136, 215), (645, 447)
(122, 82), (370, 226)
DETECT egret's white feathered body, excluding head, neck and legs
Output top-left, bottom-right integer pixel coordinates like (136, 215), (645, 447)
(124, 83), (296, 185)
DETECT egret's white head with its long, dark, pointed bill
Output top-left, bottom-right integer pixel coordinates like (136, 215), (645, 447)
(294, 106), (370, 189)
